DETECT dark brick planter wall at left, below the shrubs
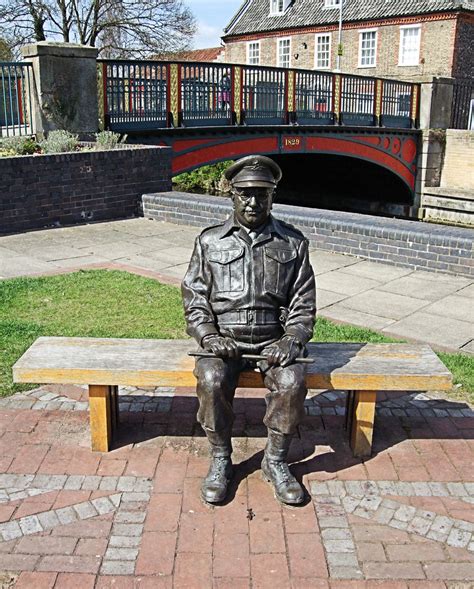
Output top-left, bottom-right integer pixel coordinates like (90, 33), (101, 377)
(0, 146), (171, 233)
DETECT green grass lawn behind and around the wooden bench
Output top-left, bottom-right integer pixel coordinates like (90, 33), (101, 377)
(0, 270), (474, 403)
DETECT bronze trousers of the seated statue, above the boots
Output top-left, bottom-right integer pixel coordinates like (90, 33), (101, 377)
(194, 358), (308, 434)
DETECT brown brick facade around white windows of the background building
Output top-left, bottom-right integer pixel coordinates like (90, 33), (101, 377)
(225, 18), (460, 81)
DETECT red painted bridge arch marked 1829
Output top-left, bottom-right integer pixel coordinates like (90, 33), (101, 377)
(131, 127), (420, 192)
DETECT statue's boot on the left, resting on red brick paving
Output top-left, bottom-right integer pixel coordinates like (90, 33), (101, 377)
(201, 428), (233, 503)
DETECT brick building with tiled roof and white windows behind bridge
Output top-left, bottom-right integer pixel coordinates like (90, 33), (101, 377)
(223, 0), (474, 81)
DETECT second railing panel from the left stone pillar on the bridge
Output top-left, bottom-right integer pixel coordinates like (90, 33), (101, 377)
(180, 63), (232, 127)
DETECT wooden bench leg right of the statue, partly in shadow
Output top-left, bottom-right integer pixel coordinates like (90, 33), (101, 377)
(351, 391), (377, 458)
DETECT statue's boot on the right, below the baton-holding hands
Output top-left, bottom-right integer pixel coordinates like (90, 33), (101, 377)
(262, 429), (304, 505)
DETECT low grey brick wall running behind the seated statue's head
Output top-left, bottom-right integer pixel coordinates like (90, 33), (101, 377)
(143, 192), (474, 276)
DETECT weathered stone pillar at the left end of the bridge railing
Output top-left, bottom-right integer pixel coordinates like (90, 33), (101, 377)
(22, 41), (99, 137)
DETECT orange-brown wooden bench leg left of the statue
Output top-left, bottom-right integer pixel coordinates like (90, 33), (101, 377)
(89, 385), (117, 452)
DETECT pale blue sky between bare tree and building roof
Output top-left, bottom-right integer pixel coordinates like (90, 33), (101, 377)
(186, 0), (242, 49)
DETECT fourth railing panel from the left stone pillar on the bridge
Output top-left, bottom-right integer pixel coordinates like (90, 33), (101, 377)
(295, 71), (335, 125)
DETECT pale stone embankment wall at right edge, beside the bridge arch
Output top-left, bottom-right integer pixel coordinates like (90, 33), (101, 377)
(421, 129), (474, 227)
